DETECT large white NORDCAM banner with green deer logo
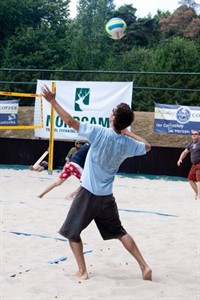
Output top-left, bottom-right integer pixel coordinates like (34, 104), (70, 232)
(34, 80), (133, 140)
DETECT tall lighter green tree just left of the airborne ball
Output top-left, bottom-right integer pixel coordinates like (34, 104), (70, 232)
(71, 0), (114, 69)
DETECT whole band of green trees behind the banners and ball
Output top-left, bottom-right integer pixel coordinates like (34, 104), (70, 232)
(0, 0), (200, 111)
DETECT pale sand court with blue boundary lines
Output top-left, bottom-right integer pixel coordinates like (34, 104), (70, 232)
(0, 167), (200, 300)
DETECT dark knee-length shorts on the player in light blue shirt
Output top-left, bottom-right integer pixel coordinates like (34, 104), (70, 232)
(59, 187), (127, 242)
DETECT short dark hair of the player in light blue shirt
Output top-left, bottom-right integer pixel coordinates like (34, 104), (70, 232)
(113, 103), (134, 130)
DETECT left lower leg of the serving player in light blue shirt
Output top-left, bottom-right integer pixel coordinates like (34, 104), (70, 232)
(69, 241), (89, 280)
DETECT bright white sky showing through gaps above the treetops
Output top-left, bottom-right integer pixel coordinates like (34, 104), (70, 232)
(70, 0), (183, 18)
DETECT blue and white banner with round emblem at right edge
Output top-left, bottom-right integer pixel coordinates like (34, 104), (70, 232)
(154, 103), (200, 135)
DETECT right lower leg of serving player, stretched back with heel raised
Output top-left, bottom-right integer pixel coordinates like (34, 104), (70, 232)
(119, 234), (152, 280)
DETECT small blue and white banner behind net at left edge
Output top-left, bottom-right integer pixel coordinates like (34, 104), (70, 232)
(0, 100), (19, 126)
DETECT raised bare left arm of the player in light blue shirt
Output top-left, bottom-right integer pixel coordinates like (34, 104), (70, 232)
(42, 85), (80, 130)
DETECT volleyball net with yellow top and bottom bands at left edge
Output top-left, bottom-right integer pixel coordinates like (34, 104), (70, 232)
(0, 91), (43, 130)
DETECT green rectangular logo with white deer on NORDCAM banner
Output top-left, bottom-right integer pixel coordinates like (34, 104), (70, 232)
(74, 88), (90, 111)
